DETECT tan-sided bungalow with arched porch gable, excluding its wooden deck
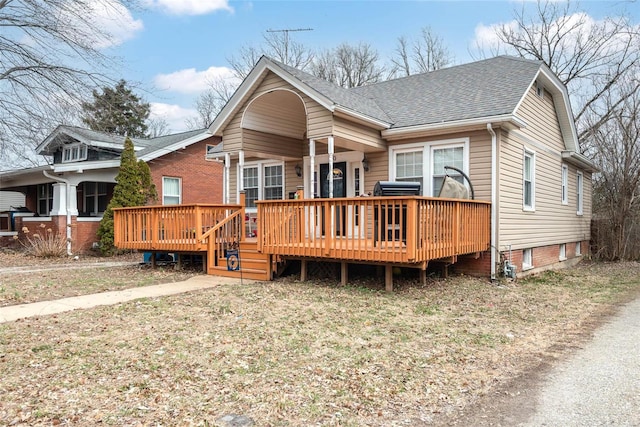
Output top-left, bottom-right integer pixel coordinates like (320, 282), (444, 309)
(198, 56), (595, 277)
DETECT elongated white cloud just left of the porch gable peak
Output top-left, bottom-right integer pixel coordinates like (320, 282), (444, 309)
(153, 67), (234, 94)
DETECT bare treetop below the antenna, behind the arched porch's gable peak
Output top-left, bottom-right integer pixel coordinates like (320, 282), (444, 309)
(227, 28), (313, 80)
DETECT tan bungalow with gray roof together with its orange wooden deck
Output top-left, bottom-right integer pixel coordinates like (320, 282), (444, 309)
(116, 56), (595, 287)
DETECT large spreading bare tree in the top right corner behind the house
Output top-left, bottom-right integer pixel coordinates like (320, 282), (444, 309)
(484, 0), (640, 140)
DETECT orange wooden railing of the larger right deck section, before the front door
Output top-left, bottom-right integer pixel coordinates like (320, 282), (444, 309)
(257, 196), (491, 263)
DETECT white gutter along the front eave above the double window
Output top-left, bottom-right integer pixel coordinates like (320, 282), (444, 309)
(382, 114), (527, 139)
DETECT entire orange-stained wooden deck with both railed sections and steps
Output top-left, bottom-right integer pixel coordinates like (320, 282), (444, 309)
(114, 196), (491, 279)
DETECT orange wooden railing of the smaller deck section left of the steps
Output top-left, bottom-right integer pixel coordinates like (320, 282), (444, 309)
(113, 204), (242, 252)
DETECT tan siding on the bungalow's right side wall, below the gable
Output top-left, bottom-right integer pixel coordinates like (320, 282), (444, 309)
(499, 132), (591, 250)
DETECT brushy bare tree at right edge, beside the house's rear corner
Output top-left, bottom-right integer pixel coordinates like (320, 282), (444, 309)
(589, 83), (640, 260)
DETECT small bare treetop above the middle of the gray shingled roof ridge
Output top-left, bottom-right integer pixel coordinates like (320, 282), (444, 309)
(391, 27), (453, 76)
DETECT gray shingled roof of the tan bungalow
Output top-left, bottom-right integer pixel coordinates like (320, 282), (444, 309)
(271, 56), (542, 128)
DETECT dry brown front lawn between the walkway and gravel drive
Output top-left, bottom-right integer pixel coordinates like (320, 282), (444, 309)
(0, 252), (640, 426)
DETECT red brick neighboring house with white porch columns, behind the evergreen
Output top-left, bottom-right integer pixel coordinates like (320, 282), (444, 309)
(0, 126), (222, 253)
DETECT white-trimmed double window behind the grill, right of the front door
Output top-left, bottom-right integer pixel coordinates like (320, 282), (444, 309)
(389, 138), (469, 196)
